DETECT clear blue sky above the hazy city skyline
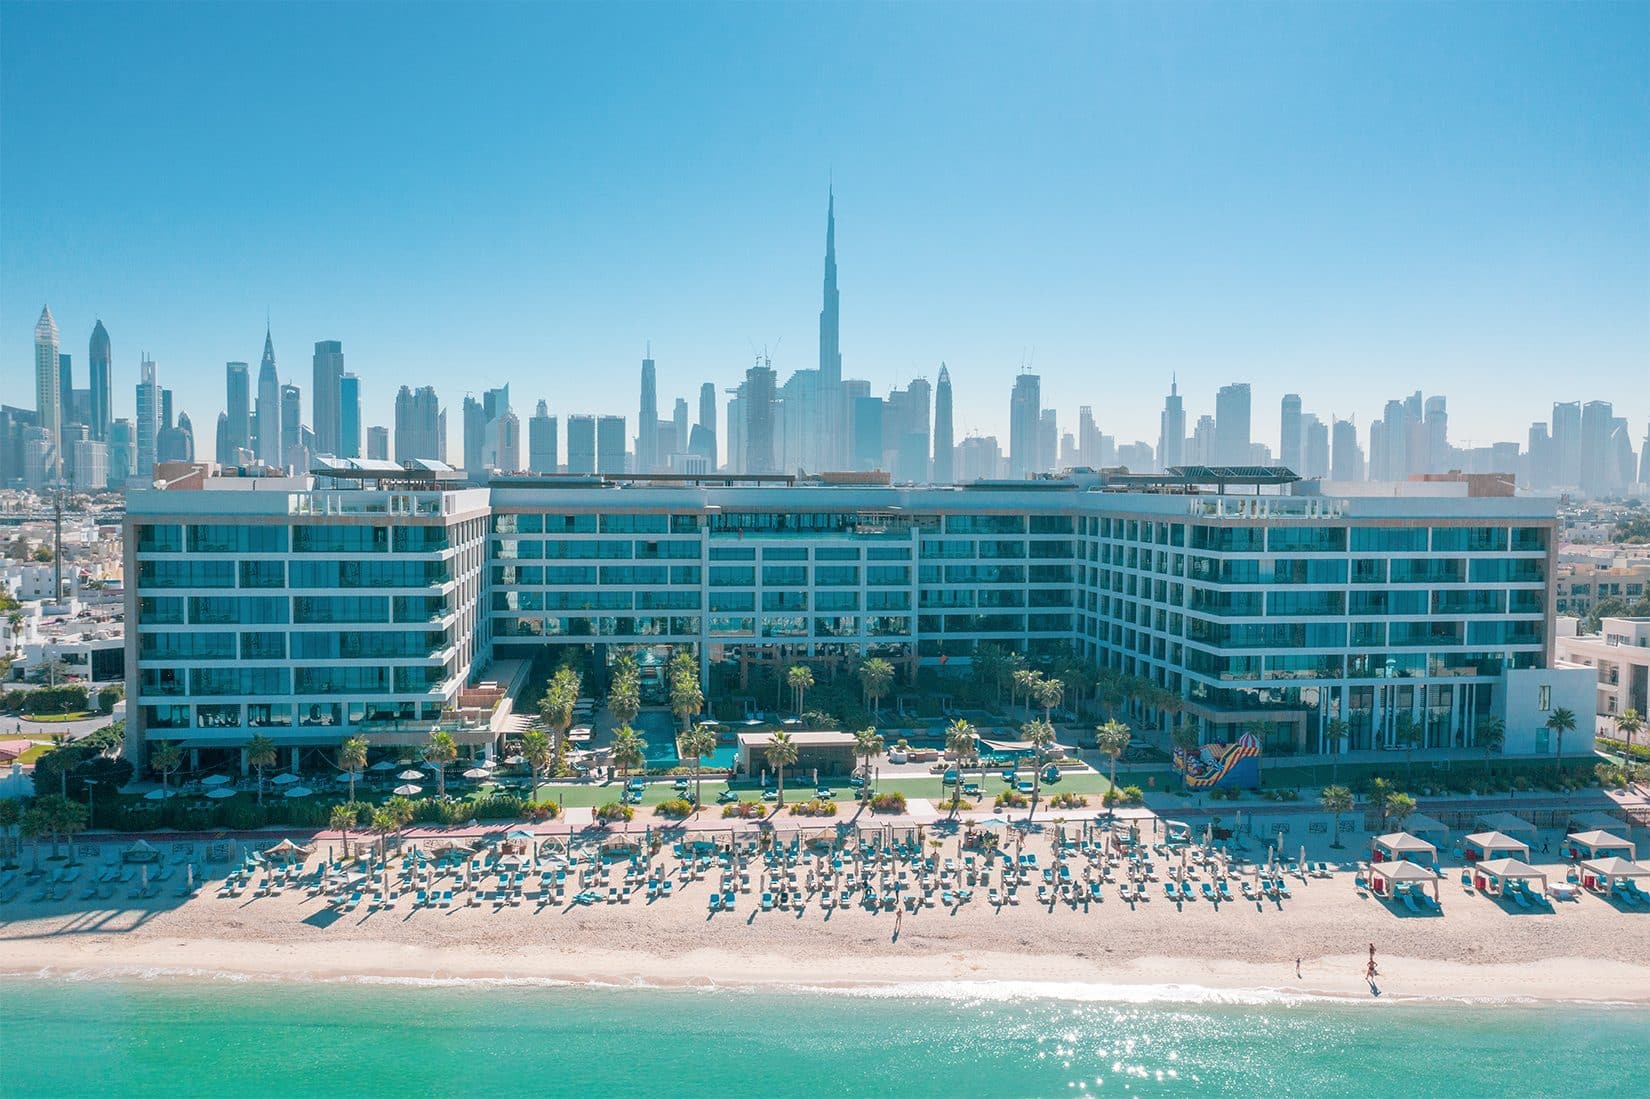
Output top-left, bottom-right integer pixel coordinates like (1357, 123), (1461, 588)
(0, 2), (1650, 455)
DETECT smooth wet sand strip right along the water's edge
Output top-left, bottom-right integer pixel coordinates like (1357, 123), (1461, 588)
(0, 936), (1650, 1008)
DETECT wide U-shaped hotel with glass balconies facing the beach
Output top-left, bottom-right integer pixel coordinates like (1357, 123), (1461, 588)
(127, 462), (1592, 754)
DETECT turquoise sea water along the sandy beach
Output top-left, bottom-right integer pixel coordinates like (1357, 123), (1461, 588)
(0, 979), (1650, 1099)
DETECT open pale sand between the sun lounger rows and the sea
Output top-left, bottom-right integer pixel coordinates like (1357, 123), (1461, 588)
(0, 821), (1650, 1003)
